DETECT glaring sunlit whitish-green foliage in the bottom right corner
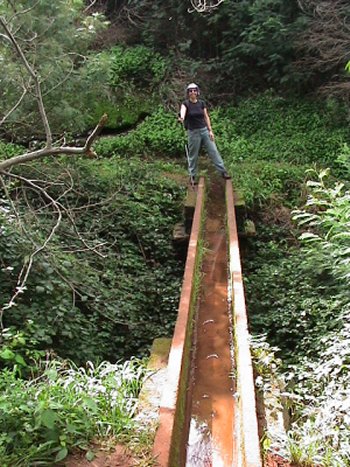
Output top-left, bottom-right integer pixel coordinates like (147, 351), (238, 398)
(287, 308), (350, 466)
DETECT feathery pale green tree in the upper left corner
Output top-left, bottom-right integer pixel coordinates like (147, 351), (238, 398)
(0, 0), (107, 138)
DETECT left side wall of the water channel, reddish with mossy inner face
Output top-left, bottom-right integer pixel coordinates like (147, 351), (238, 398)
(153, 178), (204, 467)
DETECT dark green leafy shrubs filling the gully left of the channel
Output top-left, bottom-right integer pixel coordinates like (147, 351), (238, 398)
(0, 158), (184, 363)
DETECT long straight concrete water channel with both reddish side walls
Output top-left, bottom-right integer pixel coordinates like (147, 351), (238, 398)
(154, 177), (261, 467)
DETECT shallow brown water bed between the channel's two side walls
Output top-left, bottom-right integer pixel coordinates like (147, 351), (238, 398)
(185, 177), (237, 467)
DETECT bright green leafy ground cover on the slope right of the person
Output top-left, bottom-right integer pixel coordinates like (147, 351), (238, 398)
(212, 93), (350, 165)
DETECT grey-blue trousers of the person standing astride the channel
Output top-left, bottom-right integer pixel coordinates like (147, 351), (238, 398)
(187, 127), (226, 177)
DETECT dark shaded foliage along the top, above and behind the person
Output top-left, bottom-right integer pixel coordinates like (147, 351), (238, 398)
(101, 0), (349, 100)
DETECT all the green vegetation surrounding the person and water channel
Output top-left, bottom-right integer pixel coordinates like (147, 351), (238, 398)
(0, 0), (350, 467)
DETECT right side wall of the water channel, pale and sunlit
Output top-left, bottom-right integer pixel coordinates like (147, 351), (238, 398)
(226, 181), (262, 467)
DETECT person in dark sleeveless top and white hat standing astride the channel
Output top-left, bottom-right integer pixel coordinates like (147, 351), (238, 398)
(179, 83), (231, 185)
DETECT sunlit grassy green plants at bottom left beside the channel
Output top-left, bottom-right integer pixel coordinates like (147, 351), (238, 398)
(0, 360), (145, 467)
